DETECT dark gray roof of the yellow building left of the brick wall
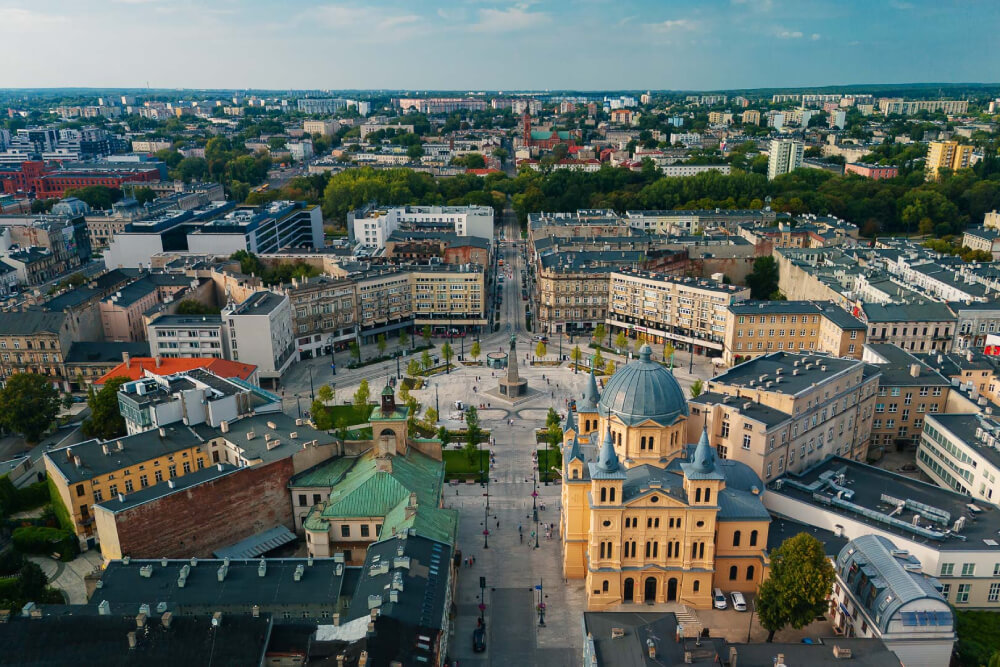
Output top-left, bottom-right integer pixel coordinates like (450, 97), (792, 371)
(45, 424), (202, 484)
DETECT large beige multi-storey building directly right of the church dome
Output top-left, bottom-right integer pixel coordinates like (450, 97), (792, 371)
(687, 352), (880, 481)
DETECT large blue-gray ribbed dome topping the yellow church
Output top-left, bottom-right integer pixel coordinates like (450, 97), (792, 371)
(597, 345), (688, 426)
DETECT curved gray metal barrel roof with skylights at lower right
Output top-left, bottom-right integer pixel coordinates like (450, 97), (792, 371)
(837, 535), (954, 632)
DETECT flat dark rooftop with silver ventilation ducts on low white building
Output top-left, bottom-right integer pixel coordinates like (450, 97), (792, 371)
(768, 456), (1000, 559)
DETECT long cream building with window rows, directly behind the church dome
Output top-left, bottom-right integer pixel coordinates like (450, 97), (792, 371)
(607, 270), (750, 353)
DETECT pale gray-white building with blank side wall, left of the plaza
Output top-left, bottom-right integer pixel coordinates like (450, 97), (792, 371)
(222, 291), (298, 383)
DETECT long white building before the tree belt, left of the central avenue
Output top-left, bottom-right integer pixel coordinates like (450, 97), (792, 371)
(348, 206), (493, 248)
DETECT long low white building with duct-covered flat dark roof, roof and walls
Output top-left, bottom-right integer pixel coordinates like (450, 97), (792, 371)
(764, 457), (1000, 609)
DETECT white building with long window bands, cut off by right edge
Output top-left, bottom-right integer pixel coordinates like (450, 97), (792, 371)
(917, 414), (1000, 505)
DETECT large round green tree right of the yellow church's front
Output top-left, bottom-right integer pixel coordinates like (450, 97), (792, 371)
(757, 533), (834, 642)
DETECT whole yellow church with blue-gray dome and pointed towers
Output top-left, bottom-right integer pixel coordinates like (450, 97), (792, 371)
(560, 345), (770, 610)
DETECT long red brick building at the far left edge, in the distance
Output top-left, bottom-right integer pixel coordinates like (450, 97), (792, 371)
(0, 162), (160, 199)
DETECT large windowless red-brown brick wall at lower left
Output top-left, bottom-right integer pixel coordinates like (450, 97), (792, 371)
(115, 458), (295, 558)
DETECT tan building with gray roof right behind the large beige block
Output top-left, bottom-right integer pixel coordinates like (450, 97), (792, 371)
(862, 343), (951, 447)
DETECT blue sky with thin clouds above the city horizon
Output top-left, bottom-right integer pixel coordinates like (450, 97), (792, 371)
(0, 0), (1000, 91)
